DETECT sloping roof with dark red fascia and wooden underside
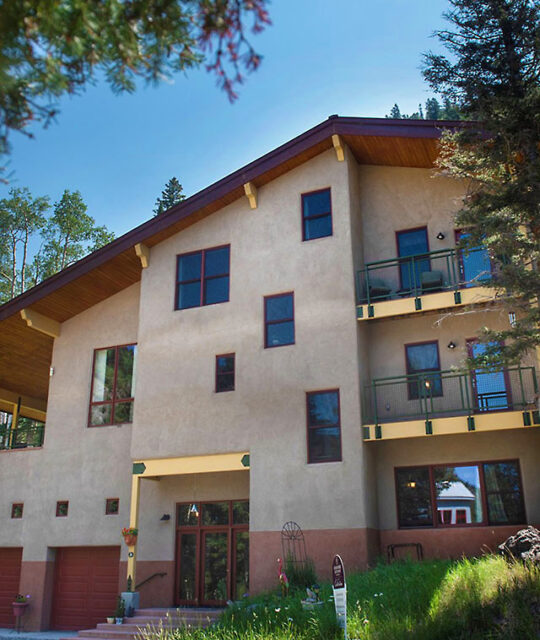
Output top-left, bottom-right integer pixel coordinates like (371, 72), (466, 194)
(0, 116), (463, 399)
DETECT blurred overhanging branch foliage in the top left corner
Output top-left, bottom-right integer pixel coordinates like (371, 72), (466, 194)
(0, 0), (269, 158)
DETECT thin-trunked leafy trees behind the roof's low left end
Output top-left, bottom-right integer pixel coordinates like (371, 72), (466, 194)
(0, 188), (114, 303)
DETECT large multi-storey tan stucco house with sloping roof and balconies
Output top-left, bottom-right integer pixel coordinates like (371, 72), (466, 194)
(0, 116), (540, 629)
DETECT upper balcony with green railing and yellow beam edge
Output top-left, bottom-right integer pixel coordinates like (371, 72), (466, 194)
(356, 248), (494, 320)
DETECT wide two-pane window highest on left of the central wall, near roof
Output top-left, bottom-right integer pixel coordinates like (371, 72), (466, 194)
(175, 246), (230, 309)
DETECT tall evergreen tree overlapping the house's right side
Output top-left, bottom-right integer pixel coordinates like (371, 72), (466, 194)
(424, 0), (540, 366)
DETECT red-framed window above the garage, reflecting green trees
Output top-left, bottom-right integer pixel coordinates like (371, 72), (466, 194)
(89, 344), (136, 427)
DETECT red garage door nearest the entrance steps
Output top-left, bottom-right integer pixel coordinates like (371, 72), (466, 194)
(51, 547), (120, 631)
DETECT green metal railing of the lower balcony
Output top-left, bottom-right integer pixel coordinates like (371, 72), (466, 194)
(363, 366), (538, 424)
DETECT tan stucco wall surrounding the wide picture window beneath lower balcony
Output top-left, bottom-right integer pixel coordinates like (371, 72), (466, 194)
(369, 430), (540, 528)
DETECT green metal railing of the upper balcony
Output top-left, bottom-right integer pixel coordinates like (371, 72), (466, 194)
(356, 247), (492, 304)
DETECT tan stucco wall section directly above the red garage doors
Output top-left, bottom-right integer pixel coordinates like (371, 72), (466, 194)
(0, 285), (139, 561)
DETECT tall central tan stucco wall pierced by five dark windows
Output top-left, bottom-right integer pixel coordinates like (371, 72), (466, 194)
(131, 151), (365, 530)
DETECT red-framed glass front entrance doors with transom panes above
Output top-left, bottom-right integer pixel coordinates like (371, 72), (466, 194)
(175, 501), (249, 606)
